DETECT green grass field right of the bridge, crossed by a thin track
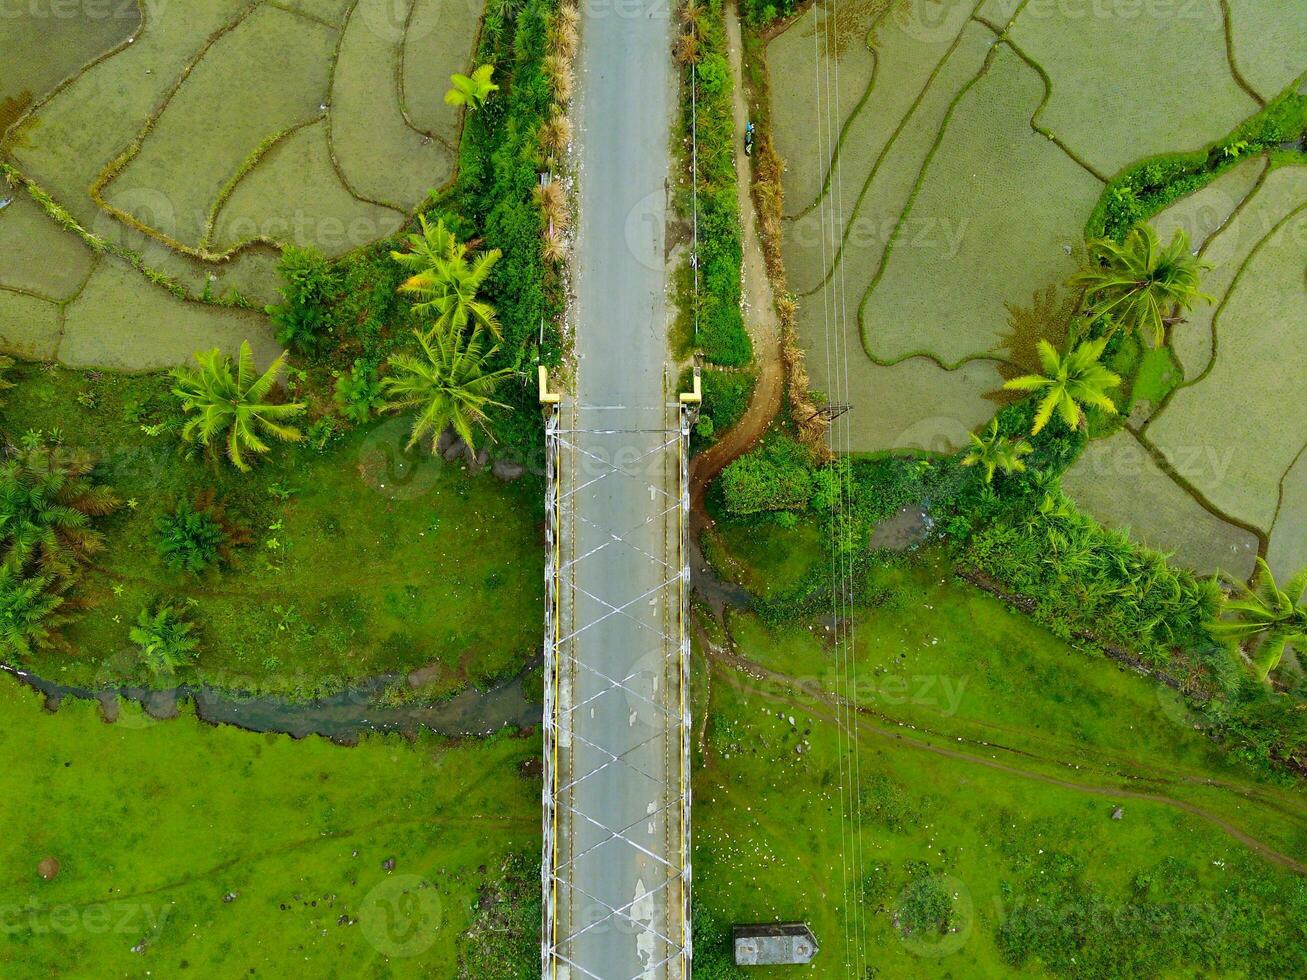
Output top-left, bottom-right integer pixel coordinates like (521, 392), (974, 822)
(695, 551), (1307, 977)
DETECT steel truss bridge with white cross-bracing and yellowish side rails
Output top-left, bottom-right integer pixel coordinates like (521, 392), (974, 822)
(541, 375), (698, 980)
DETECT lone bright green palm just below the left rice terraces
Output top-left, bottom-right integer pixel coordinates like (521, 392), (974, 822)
(173, 341), (305, 473)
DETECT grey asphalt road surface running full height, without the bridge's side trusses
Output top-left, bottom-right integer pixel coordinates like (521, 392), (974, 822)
(557, 4), (681, 980)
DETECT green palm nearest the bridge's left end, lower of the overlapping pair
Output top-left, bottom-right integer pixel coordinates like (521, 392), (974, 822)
(382, 327), (512, 452)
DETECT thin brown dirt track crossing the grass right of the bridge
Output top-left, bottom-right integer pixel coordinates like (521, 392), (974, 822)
(710, 649), (1307, 875)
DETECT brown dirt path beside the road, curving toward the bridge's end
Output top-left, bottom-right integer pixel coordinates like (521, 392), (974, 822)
(690, 3), (784, 522)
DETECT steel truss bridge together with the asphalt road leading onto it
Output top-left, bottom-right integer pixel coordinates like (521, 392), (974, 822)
(541, 5), (697, 980)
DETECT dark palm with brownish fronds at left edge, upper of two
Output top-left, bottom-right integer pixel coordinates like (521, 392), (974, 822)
(0, 447), (118, 579)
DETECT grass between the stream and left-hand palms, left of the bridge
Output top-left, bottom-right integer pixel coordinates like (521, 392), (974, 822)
(0, 366), (542, 698)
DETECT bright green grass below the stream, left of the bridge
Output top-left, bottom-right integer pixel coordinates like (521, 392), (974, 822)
(0, 678), (540, 979)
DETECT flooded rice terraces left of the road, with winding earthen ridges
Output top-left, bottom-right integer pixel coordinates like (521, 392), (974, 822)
(0, 0), (481, 370)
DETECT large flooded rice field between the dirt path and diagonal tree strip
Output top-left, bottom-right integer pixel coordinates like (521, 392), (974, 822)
(767, 0), (1302, 451)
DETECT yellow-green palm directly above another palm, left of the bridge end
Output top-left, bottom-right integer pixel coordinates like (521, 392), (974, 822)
(391, 226), (503, 337)
